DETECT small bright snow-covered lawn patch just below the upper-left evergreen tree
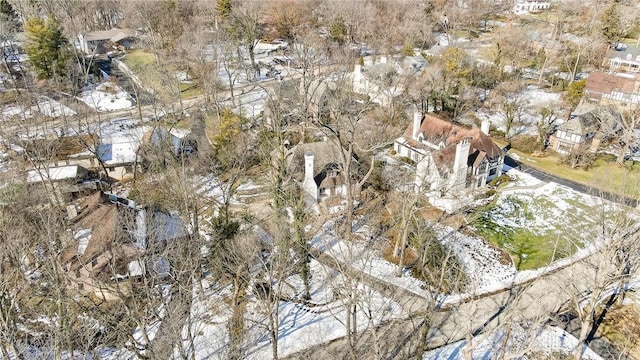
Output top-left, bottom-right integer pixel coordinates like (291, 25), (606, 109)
(78, 82), (133, 112)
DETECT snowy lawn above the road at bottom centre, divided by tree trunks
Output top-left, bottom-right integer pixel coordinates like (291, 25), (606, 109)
(183, 260), (403, 359)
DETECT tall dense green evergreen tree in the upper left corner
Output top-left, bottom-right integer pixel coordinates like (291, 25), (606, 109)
(24, 17), (68, 79)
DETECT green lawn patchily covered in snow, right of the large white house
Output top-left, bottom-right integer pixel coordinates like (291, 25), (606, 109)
(469, 180), (626, 270)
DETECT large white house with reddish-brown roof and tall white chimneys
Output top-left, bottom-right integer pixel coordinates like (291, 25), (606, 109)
(394, 113), (504, 212)
